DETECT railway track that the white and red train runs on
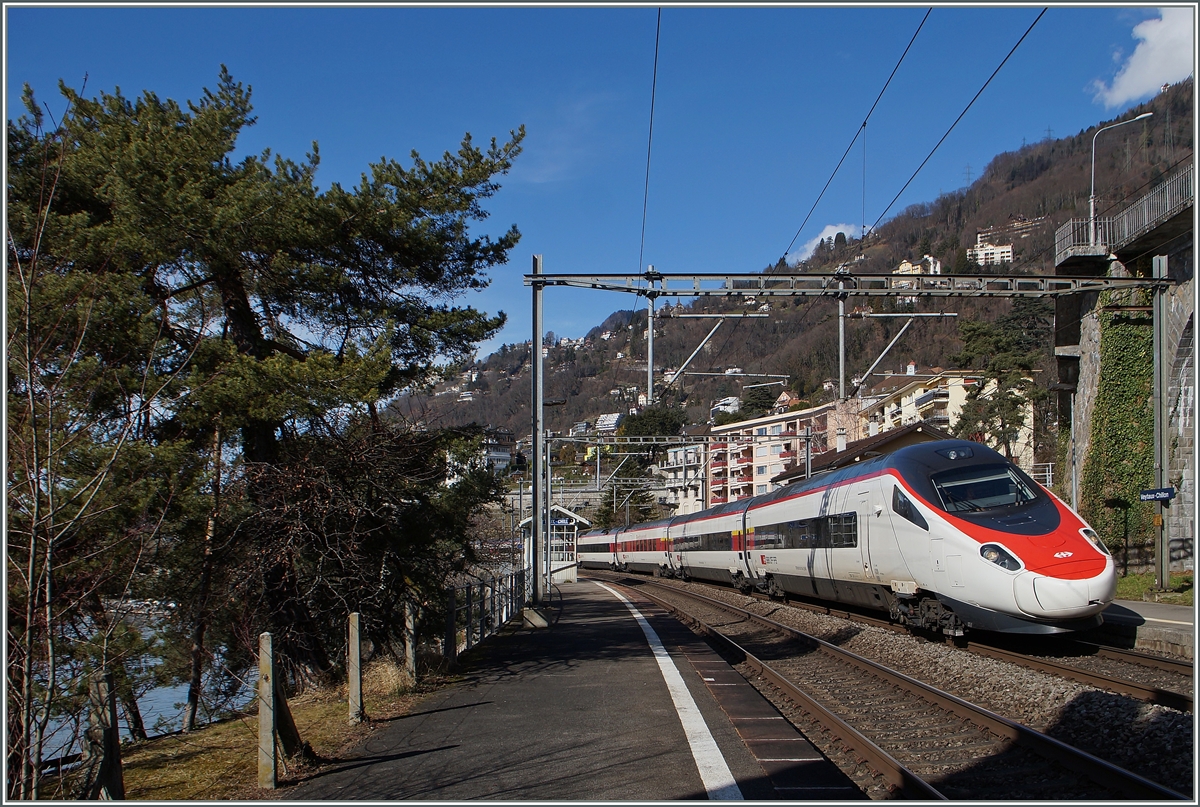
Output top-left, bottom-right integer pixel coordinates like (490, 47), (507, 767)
(672, 574), (1194, 712)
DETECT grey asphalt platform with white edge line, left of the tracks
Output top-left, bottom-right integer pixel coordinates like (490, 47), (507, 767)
(295, 580), (865, 801)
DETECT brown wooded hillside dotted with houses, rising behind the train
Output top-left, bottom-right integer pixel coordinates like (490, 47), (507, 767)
(403, 79), (1193, 459)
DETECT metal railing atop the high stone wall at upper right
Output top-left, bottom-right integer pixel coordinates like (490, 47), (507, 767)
(1054, 163), (1195, 265)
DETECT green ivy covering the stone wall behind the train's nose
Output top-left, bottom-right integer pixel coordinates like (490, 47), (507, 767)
(1079, 295), (1157, 563)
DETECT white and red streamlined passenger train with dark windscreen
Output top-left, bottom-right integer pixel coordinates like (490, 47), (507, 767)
(577, 441), (1116, 635)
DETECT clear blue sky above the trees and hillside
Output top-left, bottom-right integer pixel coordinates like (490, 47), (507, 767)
(5, 4), (1195, 354)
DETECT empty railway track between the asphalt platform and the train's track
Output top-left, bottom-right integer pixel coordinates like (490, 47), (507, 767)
(604, 579), (1184, 800)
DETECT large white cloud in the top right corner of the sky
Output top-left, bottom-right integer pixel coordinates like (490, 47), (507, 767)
(1092, 7), (1195, 109)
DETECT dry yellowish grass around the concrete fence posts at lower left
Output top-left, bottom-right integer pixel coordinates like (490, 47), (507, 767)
(122, 663), (438, 801)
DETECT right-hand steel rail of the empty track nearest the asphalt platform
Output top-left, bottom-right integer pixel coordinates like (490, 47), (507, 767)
(642, 581), (1189, 801)
